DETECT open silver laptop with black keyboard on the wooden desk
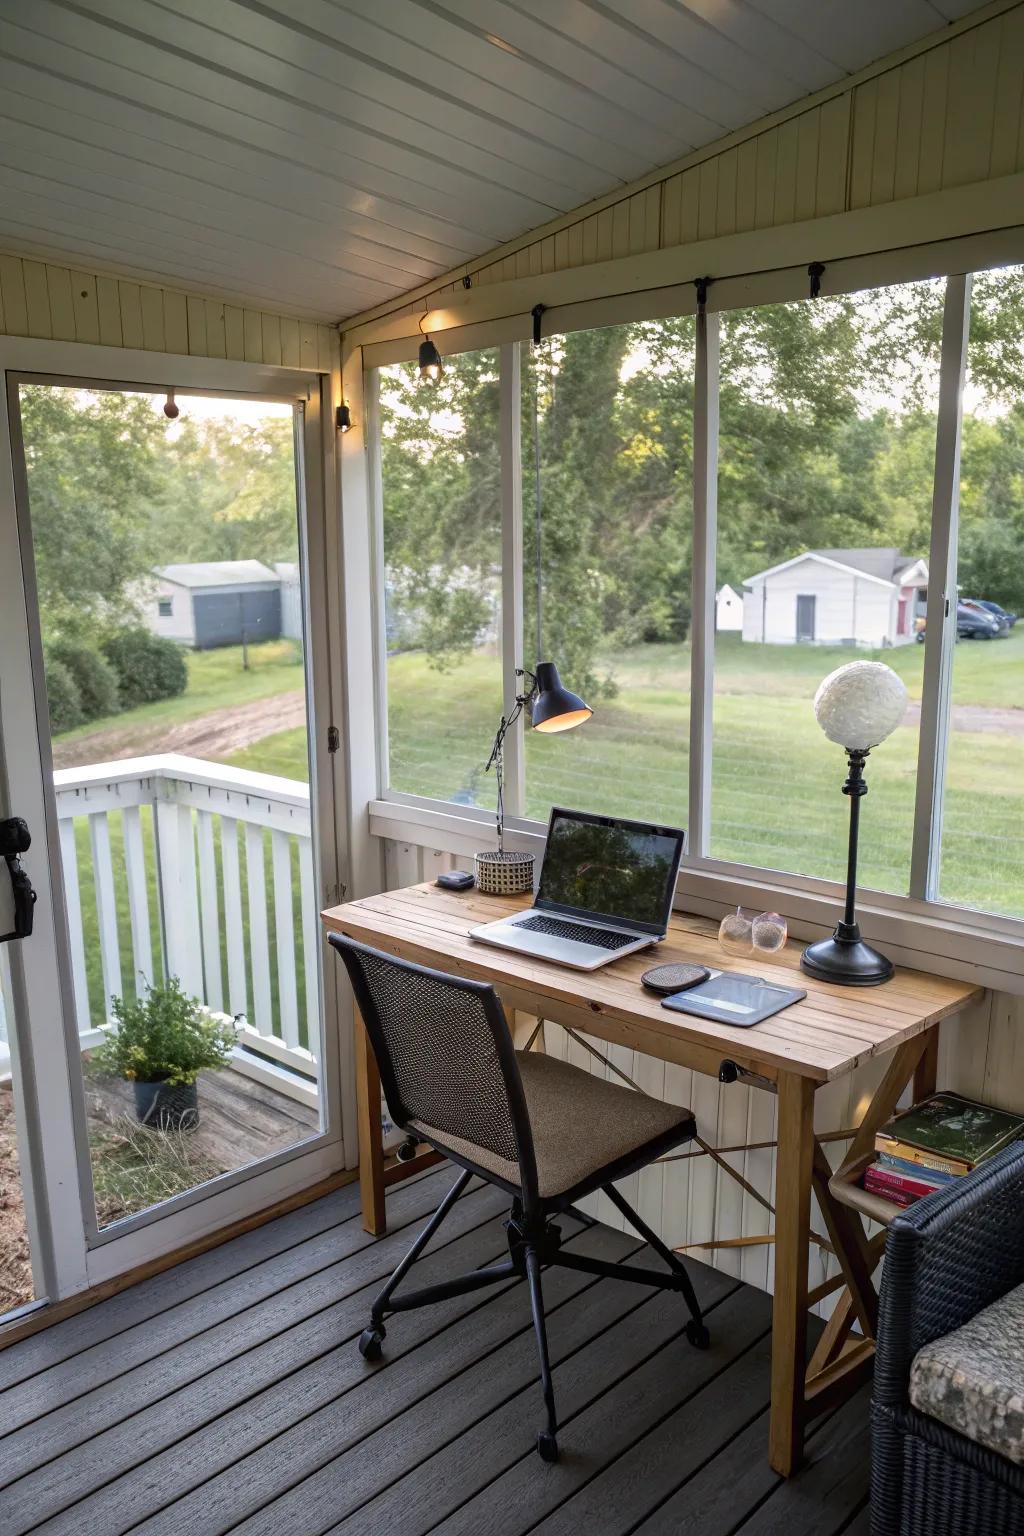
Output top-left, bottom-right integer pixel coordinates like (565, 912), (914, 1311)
(470, 806), (686, 971)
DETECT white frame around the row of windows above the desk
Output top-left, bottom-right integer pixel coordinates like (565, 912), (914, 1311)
(363, 229), (1024, 992)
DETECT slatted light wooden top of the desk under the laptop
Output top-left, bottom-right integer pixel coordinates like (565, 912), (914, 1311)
(322, 885), (983, 1083)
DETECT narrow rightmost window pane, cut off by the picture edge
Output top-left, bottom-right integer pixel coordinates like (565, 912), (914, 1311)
(938, 267), (1024, 917)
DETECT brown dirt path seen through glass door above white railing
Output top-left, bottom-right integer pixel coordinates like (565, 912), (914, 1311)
(54, 688), (306, 768)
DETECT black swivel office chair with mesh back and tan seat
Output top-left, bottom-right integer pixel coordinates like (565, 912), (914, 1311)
(329, 934), (711, 1461)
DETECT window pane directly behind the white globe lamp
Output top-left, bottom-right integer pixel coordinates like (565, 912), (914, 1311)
(709, 283), (944, 894)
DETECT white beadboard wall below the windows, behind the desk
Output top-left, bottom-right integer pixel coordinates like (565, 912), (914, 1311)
(384, 839), (1024, 1316)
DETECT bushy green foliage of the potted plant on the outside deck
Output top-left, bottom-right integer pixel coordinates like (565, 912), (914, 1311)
(89, 977), (235, 1087)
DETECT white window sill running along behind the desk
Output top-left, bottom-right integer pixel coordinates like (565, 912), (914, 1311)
(368, 796), (1024, 995)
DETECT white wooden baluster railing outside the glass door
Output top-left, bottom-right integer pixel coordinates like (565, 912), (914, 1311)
(42, 754), (319, 1103)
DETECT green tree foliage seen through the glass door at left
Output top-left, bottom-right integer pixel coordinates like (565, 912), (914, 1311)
(20, 386), (296, 641)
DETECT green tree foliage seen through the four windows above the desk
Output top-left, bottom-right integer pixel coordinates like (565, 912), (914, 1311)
(381, 269), (1024, 693)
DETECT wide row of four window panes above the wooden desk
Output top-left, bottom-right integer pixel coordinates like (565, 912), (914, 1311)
(379, 259), (1024, 917)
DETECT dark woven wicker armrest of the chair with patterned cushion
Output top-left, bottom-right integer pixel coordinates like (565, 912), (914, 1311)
(875, 1141), (1024, 1405)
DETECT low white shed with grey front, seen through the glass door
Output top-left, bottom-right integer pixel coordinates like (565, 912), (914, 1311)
(135, 561), (281, 651)
